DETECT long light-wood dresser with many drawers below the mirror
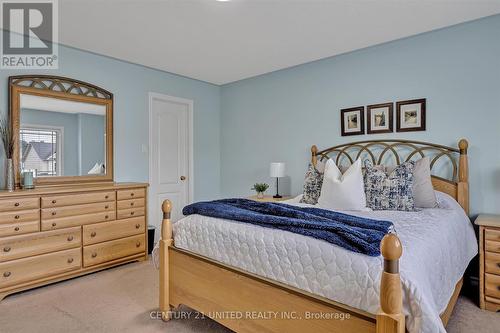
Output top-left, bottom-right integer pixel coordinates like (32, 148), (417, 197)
(0, 183), (147, 300)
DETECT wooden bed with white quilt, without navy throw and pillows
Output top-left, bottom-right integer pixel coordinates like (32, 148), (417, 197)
(160, 140), (477, 333)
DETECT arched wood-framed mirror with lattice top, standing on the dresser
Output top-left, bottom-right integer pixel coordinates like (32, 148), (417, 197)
(11, 76), (112, 184)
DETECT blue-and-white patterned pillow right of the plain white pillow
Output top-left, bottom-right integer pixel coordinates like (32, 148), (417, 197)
(364, 160), (415, 211)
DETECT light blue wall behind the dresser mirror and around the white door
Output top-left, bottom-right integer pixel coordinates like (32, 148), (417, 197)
(0, 41), (220, 200)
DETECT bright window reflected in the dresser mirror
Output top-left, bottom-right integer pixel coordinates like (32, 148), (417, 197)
(19, 126), (62, 176)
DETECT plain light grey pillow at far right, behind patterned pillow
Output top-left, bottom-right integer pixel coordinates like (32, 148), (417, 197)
(413, 157), (437, 208)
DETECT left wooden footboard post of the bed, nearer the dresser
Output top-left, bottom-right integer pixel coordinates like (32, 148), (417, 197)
(160, 200), (174, 321)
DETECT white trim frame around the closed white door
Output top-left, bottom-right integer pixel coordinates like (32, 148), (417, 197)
(148, 92), (194, 226)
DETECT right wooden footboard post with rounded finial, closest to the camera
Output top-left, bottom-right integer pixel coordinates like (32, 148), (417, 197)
(377, 234), (405, 333)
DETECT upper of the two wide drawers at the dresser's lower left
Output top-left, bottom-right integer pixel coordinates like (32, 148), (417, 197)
(0, 227), (82, 262)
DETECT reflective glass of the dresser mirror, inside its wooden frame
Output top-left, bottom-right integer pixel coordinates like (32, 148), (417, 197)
(19, 94), (106, 177)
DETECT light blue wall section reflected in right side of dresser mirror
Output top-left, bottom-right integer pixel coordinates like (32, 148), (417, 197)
(78, 113), (106, 175)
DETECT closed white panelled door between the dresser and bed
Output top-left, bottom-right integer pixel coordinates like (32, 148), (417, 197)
(149, 93), (193, 240)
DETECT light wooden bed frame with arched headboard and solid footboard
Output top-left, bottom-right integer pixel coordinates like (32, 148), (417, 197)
(159, 139), (469, 333)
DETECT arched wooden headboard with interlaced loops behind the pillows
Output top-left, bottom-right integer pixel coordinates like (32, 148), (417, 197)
(311, 139), (469, 215)
